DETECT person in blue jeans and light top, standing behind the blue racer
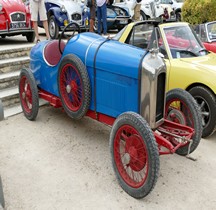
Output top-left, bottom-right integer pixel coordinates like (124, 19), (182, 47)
(97, 0), (108, 35)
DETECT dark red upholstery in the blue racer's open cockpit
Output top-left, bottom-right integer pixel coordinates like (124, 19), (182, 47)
(44, 40), (65, 66)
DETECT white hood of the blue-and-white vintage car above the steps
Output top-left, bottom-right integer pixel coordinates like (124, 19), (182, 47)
(45, 0), (82, 14)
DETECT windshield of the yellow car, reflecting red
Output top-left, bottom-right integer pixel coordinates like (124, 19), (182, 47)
(162, 25), (208, 58)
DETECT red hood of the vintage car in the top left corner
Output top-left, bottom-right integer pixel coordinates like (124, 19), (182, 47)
(0, 0), (26, 14)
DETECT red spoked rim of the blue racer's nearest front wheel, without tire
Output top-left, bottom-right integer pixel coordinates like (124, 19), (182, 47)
(114, 125), (149, 188)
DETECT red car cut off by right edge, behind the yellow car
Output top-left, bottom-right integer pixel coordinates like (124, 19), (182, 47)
(194, 21), (216, 53)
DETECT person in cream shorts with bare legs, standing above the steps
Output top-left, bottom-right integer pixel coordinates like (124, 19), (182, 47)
(30, 0), (50, 43)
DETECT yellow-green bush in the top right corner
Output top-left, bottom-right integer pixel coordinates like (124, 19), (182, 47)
(181, 0), (216, 24)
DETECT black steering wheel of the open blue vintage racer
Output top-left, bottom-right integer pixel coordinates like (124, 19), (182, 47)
(59, 22), (81, 54)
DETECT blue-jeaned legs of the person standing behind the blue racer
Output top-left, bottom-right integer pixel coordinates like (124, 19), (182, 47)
(97, 2), (107, 34)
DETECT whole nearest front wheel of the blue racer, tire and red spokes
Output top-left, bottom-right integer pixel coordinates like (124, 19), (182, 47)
(110, 112), (160, 199)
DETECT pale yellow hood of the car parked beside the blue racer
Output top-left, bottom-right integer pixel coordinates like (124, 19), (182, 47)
(180, 53), (216, 72)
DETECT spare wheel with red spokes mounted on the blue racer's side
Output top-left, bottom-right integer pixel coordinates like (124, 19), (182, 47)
(58, 54), (91, 119)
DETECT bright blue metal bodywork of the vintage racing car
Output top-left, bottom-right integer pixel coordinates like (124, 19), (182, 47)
(30, 32), (146, 117)
